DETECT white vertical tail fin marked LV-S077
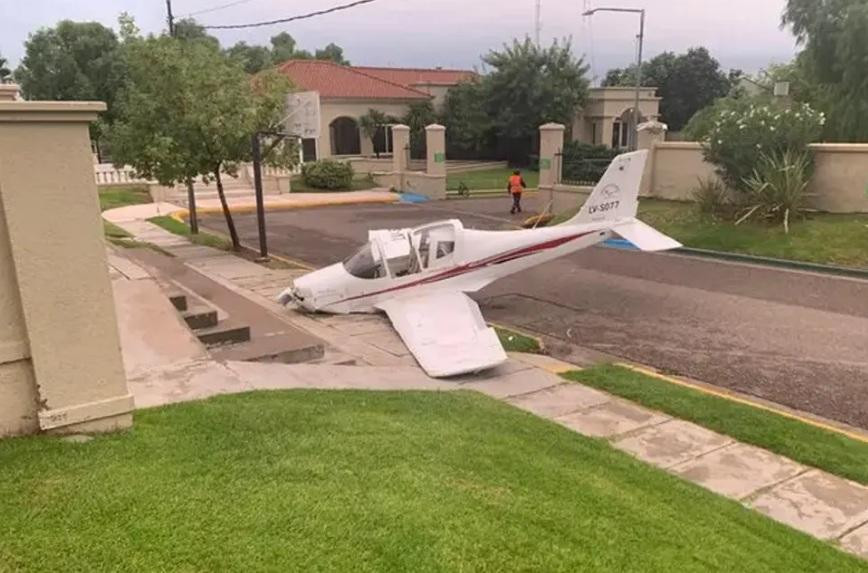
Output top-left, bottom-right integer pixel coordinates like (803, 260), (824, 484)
(564, 150), (648, 225)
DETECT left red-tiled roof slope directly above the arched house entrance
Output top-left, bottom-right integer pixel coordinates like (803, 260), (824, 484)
(278, 60), (431, 100)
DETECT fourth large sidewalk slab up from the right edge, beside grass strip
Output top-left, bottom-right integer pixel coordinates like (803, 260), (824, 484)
(556, 399), (671, 438)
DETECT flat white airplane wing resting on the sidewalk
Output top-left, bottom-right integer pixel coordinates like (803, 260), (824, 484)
(377, 292), (506, 378)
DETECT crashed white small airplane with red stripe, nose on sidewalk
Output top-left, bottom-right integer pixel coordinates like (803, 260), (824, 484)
(278, 151), (681, 377)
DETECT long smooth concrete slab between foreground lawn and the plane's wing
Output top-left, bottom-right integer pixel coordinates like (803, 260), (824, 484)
(226, 361), (460, 390)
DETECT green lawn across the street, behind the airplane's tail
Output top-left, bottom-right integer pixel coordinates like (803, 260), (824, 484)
(551, 199), (868, 269)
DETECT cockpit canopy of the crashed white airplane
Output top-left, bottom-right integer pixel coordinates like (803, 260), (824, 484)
(344, 219), (463, 279)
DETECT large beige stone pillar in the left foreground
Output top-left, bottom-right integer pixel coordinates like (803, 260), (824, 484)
(0, 101), (133, 436)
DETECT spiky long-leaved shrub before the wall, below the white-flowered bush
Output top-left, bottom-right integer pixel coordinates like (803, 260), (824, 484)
(736, 150), (812, 233)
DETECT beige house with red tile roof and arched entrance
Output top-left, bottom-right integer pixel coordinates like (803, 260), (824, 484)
(278, 60), (476, 158)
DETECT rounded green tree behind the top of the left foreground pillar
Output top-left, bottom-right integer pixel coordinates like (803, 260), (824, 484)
(15, 20), (125, 139)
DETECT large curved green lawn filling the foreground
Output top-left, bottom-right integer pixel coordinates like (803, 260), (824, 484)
(0, 391), (866, 573)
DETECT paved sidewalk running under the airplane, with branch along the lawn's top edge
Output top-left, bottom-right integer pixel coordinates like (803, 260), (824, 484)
(103, 204), (868, 559)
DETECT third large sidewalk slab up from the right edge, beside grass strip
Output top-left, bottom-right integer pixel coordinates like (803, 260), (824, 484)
(614, 420), (733, 468)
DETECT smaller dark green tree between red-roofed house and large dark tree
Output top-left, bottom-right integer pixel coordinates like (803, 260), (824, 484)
(440, 79), (495, 159)
